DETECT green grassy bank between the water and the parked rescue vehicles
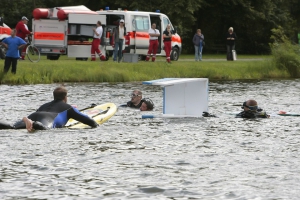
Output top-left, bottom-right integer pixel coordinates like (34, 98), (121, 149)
(0, 55), (290, 84)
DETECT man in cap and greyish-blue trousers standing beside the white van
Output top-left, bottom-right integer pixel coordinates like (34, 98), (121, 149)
(113, 19), (126, 62)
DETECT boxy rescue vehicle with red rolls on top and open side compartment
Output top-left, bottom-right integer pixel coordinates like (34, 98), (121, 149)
(32, 5), (106, 60)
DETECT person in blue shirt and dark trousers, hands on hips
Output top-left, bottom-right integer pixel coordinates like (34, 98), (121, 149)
(1, 29), (26, 74)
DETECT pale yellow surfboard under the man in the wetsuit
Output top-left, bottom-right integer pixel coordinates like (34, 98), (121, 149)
(65, 103), (118, 128)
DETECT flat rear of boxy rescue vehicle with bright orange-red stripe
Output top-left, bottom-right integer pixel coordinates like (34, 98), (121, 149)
(32, 19), (68, 54)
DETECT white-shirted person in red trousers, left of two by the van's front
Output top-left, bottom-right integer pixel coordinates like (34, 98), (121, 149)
(146, 23), (160, 62)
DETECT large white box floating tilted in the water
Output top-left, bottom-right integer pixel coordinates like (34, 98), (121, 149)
(143, 78), (209, 118)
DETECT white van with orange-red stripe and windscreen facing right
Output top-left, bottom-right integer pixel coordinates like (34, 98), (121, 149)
(97, 9), (182, 60)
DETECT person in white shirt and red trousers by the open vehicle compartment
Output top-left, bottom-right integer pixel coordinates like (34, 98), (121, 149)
(91, 21), (106, 61)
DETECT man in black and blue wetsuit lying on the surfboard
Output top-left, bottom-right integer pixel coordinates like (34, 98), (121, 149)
(0, 87), (98, 131)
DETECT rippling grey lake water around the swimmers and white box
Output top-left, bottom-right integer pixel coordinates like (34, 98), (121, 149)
(0, 80), (300, 200)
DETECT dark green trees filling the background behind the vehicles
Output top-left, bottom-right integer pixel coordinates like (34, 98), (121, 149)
(0, 0), (300, 54)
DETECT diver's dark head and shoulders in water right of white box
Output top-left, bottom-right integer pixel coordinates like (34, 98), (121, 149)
(236, 99), (270, 118)
